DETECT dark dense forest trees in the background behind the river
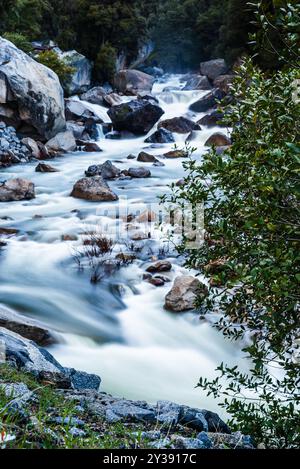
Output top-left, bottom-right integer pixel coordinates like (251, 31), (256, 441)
(0, 0), (297, 72)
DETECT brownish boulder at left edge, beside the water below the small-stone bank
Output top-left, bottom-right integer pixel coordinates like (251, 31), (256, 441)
(0, 178), (35, 202)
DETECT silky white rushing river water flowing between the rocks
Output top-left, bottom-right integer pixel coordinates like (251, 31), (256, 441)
(0, 76), (241, 410)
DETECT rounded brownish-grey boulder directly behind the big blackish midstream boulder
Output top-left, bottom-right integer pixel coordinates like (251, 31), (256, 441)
(114, 70), (154, 96)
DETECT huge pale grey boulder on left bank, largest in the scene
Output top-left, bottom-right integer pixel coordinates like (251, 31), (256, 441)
(0, 37), (66, 140)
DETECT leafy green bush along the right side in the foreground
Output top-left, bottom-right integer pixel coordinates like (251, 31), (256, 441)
(164, 5), (300, 448)
